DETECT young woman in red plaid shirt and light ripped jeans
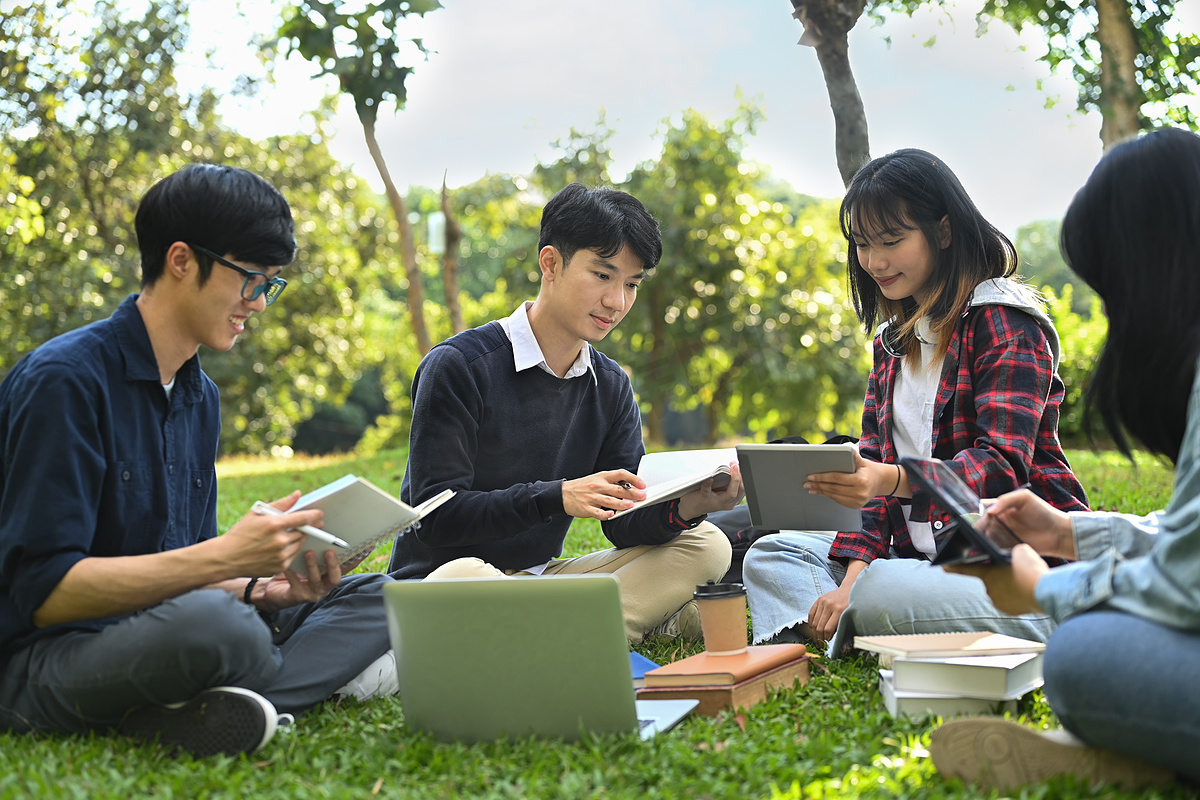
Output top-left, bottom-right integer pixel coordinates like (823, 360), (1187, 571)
(743, 150), (1087, 654)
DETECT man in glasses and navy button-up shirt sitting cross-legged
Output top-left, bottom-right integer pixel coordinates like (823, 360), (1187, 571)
(0, 164), (390, 756)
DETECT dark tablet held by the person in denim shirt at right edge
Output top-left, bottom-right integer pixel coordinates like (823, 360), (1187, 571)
(900, 458), (1021, 566)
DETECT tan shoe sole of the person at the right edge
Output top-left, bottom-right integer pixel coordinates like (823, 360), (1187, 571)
(929, 718), (1175, 790)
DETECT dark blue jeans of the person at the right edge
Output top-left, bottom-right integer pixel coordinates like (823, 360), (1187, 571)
(1044, 610), (1200, 781)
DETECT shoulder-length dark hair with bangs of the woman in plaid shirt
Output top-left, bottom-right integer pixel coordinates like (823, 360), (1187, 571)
(840, 149), (1018, 357)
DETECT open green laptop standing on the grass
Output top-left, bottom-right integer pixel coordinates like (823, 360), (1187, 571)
(384, 575), (696, 742)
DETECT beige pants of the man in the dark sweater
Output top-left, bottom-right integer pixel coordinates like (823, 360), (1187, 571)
(425, 522), (732, 644)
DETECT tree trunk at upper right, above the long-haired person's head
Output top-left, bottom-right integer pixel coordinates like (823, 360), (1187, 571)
(1096, 0), (1141, 152)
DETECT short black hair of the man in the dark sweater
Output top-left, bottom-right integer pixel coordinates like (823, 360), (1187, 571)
(538, 184), (662, 272)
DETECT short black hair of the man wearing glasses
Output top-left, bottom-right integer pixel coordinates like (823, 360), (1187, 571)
(133, 164), (296, 287)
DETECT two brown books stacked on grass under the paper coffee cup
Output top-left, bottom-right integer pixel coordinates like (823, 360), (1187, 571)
(637, 644), (809, 716)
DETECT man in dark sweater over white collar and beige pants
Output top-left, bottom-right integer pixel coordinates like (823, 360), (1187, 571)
(389, 184), (743, 642)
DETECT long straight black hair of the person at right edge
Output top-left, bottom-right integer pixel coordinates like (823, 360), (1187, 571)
(1061, 128), (1200, 462)
